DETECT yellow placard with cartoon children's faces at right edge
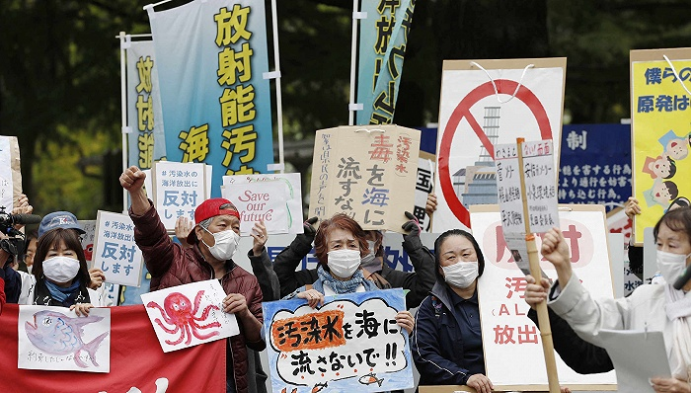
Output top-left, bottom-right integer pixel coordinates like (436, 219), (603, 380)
(630, 48), (692, 245)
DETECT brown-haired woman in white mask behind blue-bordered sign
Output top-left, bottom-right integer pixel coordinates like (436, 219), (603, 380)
(285, 214), (413, 333)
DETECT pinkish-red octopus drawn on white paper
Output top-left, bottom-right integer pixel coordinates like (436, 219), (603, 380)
(147, 290), (221, 345)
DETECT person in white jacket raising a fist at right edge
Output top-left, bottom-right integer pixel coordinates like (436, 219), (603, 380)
(526, 207), (691, 393)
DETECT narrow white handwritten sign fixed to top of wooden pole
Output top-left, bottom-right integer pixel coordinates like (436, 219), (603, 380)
(521, 140), (559, 233)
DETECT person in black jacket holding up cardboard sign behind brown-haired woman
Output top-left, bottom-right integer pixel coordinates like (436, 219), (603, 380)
(274, 214), (435, 308)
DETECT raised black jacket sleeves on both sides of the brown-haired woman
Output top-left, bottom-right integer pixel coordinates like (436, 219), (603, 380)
(274, 229), (435, 308)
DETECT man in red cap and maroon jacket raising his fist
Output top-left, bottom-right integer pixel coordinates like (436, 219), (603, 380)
(120, 166), (271, 393)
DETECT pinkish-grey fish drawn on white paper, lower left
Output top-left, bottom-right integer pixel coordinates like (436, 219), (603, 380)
(25, 311), (108, 368)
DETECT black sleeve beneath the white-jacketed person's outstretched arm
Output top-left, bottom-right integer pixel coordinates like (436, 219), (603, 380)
(527, 308), (613, 374)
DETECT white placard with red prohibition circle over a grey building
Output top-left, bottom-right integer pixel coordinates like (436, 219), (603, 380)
(433, 58), (567, 232)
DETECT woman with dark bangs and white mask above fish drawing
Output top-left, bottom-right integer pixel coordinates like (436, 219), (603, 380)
(28, 227), (105, 316)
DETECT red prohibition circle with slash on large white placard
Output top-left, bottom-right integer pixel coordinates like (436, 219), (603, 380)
(437, 79), (553, 228)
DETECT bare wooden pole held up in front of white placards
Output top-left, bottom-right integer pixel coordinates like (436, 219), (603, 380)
(517, 138), (560, 393)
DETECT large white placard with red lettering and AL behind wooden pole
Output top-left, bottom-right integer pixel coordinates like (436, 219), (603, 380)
(471, 205), (615, 391)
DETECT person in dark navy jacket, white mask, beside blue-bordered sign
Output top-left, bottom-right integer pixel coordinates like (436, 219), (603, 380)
(411, 229), (493, 393)
